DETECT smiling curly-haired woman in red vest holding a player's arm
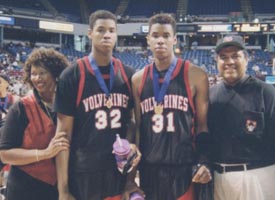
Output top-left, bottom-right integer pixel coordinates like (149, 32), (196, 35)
(0, 48), (69, 200)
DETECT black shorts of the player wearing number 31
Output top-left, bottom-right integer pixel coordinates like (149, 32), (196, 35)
(140, 164), (192, 200)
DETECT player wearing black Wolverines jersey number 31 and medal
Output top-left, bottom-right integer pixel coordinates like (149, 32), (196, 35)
(132, 14), (211, 200)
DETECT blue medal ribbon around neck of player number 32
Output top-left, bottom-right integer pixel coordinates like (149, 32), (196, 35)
(89, 55), (115, 98)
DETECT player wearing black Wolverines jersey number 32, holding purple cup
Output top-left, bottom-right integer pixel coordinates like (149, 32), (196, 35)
(55, 10), (143, 200)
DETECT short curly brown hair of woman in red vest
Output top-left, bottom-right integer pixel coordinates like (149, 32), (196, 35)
(24, 47), (69, 87)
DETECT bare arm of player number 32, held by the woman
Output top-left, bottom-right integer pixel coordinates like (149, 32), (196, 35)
(56, 113), (75, 200)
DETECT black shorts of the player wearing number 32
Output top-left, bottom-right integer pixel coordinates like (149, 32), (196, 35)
(70, 168), (126, 200)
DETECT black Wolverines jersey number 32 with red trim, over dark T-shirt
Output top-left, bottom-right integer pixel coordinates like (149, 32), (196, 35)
(55, 57), (134, 172)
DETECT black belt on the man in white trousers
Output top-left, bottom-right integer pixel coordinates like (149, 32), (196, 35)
(213, 161), (275, 173)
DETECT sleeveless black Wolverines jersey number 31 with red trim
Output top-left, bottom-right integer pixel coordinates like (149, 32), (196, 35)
(139, 59), (195, 165)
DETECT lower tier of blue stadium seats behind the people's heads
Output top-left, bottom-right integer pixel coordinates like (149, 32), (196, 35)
(3, 45), (272, 75)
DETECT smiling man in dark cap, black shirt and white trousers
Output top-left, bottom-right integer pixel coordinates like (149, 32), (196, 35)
(208, 35), (275, 200)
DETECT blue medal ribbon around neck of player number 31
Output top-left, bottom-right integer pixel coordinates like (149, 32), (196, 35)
(153, 58), (178, 104)
